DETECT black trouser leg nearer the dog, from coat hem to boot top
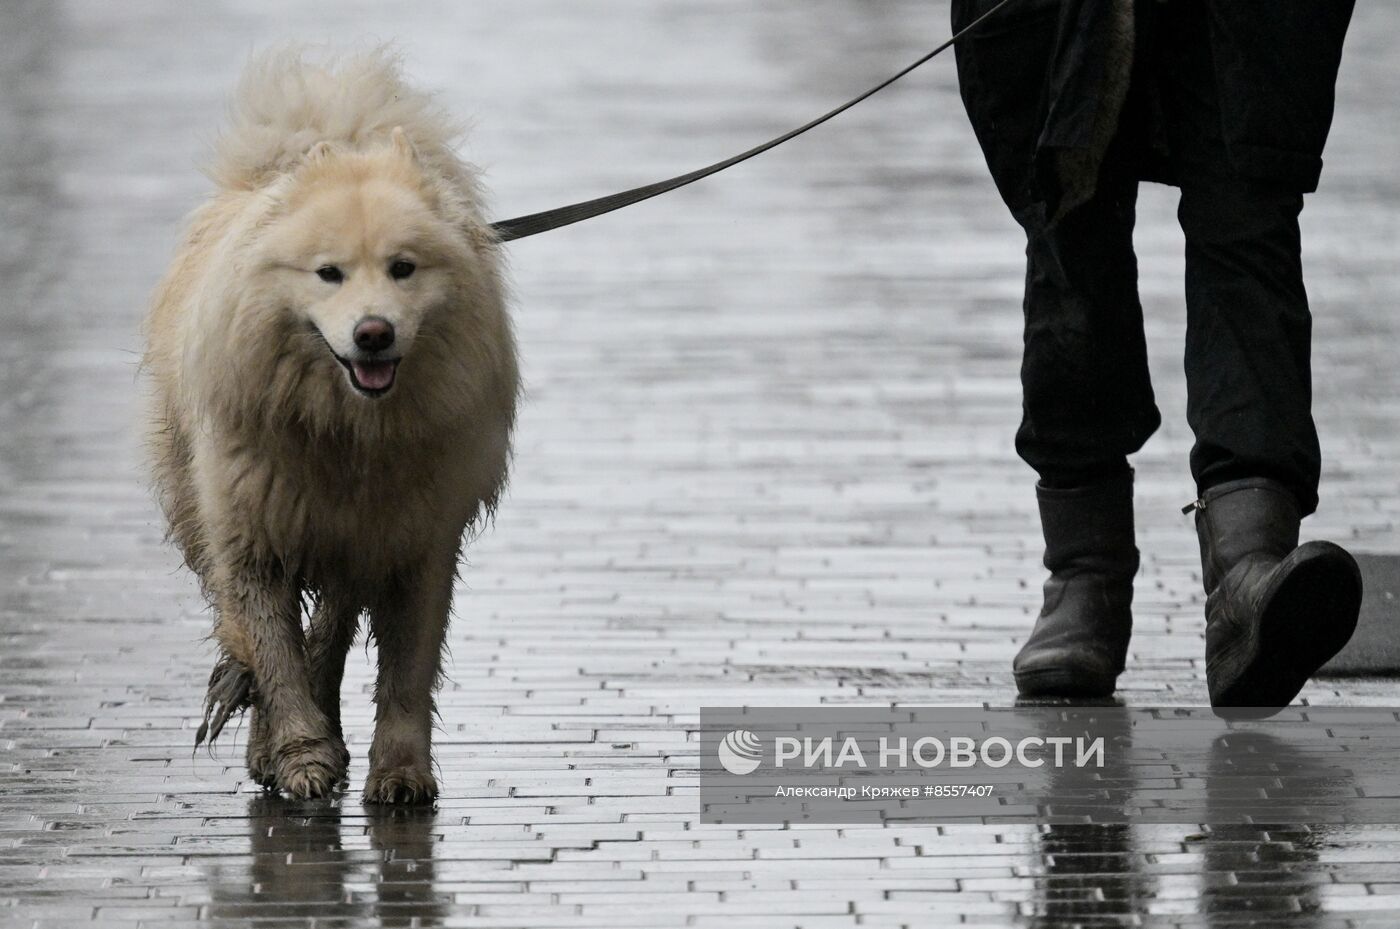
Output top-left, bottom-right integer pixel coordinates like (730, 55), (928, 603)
(1016, 179), (1161, 487)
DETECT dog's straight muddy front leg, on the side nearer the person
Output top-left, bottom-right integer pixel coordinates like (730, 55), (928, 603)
(364, 553), (455, 803)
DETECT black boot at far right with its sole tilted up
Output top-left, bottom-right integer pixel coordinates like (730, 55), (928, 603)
(1187, 477), (1361, 718)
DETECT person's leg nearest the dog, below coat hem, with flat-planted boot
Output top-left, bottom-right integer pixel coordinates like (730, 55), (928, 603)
(1012, 172), (1161, 697)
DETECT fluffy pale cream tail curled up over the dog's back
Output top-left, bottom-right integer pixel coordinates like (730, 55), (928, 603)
(206, 46), (462, 190)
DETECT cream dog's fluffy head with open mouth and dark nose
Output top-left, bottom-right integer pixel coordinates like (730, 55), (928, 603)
(215, 130), (515, 436)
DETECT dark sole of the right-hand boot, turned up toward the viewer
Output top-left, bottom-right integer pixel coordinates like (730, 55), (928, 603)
(1207, 541), (1361, 719)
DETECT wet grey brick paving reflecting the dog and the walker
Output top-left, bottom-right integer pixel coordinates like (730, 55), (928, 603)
(0, 0), (1400, 929)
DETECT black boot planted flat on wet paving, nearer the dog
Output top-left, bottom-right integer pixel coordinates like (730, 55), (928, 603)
(1011, 471), (1138, 698)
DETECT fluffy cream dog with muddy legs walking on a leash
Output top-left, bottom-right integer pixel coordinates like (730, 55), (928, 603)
(144, 49), (518, 803)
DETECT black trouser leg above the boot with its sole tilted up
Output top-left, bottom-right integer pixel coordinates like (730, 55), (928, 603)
(1179, 173), (1322, 516)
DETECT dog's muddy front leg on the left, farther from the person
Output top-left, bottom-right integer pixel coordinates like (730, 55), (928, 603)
(214, 558), (346, 797)
